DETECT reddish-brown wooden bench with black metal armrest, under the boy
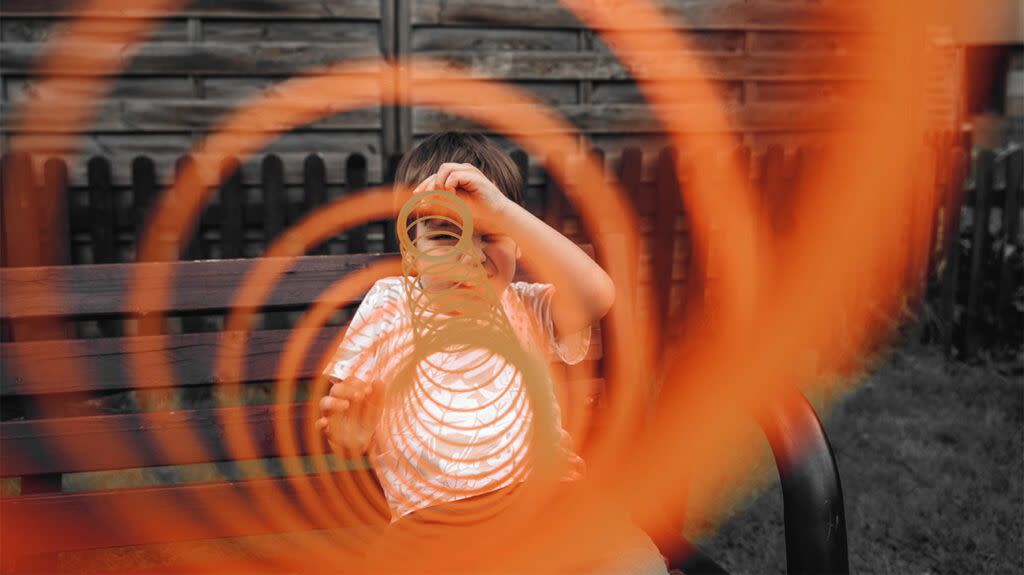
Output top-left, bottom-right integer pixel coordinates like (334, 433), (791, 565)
(0, 248), (846, 573)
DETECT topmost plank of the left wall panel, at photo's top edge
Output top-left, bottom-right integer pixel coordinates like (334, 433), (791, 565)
(3, 0), (380, 19)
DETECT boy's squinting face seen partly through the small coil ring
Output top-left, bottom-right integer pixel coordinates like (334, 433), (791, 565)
(415, 218), (519, 302)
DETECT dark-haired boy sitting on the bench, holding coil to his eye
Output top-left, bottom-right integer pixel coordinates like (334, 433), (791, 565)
(317, 132), (666, 574)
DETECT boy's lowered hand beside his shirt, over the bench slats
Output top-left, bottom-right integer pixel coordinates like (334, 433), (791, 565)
(316, 378), (384, 452)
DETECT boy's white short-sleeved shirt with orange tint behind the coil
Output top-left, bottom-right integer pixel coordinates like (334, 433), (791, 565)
(325, 276), (591, 521)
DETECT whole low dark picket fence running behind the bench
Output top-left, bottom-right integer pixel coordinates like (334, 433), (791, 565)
(0, 136), (1024, 356)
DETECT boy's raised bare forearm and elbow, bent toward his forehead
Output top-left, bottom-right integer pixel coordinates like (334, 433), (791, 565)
(496, 201), (615, 334)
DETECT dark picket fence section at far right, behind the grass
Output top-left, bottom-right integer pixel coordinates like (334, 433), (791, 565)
(923, 144), (1024, 358)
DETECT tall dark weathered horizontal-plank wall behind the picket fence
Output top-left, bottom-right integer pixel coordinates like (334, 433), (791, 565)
(0, 0), (892, 181)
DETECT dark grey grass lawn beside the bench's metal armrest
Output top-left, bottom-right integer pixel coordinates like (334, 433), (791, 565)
(701, 341), (1024, 574)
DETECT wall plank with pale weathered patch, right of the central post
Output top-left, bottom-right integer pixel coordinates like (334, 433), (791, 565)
(407, 51), (863, 81)
